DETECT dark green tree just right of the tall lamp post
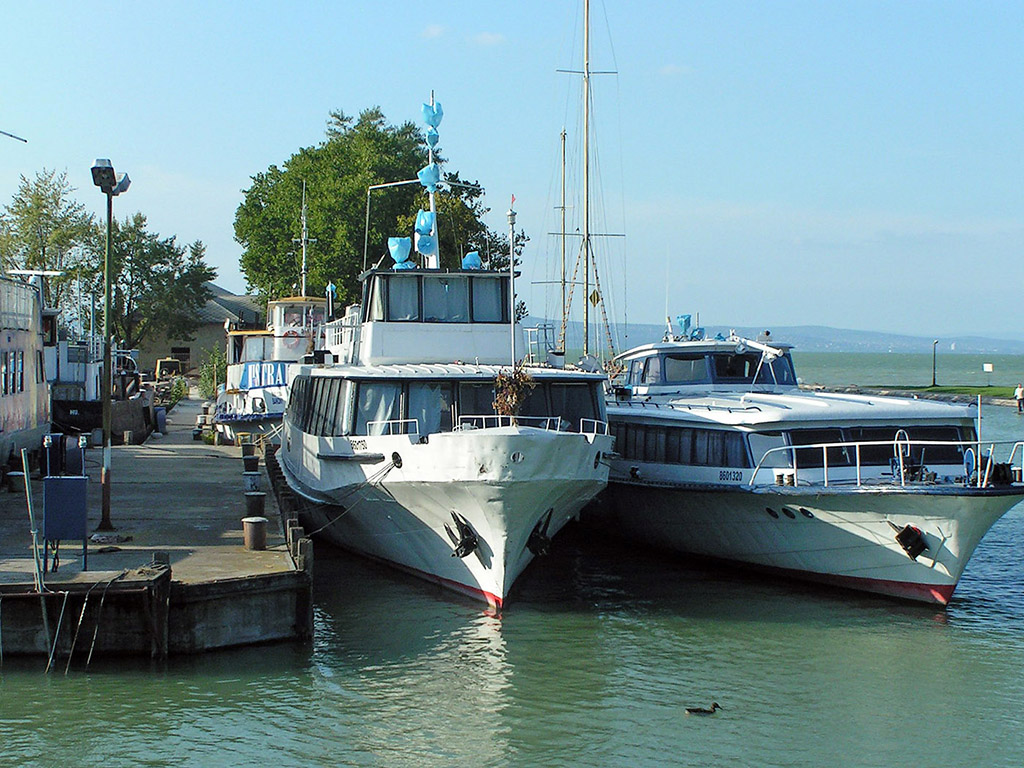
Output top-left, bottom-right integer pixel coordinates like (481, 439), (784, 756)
(80, 213), (216, 349)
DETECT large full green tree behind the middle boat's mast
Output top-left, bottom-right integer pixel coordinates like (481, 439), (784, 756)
(234, 108), (519, 306)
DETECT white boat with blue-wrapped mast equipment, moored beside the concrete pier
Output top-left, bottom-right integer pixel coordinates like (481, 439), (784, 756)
(278, 269), (611, 607)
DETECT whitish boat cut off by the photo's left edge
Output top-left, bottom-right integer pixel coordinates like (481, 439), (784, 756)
(0, 278), (49, 471)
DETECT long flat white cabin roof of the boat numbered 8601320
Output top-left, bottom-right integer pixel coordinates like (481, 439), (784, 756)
(608, 389), (978, 429)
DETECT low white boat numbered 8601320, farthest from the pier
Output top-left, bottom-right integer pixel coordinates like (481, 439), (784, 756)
(602, 325), (1024, 604)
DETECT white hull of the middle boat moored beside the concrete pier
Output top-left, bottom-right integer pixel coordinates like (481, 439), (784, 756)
(280, 427), (611, 608)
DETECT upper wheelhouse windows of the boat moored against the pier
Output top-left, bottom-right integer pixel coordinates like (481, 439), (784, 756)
(367, 273), (509, 323)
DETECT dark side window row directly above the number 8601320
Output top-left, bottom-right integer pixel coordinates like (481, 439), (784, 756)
(611, 422), (751, 467)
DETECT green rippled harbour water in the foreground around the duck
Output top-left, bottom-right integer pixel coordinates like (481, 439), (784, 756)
(0, 355), (1024, 768)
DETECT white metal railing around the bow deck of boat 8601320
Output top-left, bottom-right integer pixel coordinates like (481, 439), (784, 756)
(750, 436), (1024, 487)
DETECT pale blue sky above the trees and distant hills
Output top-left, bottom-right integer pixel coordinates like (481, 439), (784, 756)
(0, 0), (1024, 342)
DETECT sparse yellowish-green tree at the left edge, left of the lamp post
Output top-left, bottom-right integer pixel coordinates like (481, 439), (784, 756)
(0, 168), (96, 309)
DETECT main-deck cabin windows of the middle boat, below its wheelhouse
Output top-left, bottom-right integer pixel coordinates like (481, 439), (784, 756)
(288, 376), (603, 435)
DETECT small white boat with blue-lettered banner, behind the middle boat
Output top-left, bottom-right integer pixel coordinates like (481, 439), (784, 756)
(213, 296), (327, 442)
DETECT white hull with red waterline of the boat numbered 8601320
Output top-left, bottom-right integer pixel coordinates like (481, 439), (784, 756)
(604, 482), (1024, 605)
